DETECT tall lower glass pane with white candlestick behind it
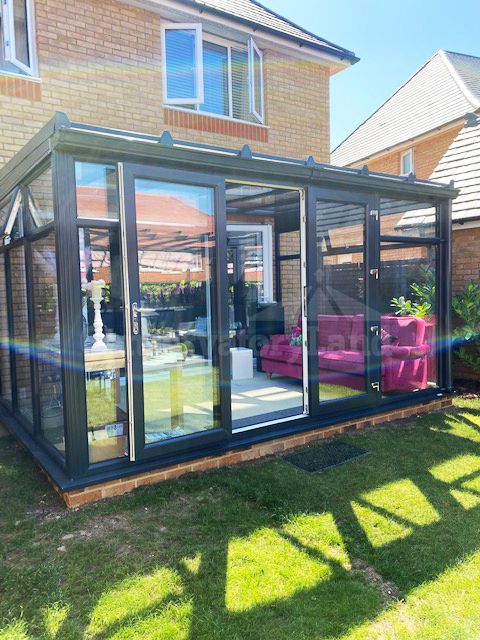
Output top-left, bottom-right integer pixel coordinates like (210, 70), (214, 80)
(79, 229), (128, 463)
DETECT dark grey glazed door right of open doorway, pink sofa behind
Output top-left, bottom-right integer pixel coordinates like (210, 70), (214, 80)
(308, 188), (381, 416)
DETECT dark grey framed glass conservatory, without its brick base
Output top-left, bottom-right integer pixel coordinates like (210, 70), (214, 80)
(0, 113), (456, 492)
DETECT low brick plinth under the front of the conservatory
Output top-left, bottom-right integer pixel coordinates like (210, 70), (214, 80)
(62, 398), (452, 508)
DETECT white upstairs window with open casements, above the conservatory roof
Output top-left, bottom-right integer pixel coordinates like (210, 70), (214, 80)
(162, 23), (264, 122)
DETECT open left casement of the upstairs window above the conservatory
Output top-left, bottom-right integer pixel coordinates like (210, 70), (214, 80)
(162, 23), (204, 105)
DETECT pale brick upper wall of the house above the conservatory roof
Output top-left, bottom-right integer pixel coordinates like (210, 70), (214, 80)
(0, 0), (330, 166)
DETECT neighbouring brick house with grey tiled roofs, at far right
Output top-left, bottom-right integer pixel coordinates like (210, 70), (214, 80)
(332, 50), (480, 300)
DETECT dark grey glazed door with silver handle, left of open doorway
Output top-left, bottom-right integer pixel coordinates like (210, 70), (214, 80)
(121, 164), (230, 459)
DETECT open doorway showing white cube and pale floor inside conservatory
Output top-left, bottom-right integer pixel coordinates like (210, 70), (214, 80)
(227, 184), (304, 429)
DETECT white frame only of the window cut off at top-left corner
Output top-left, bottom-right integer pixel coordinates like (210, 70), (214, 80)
(0, 0), (37, 76)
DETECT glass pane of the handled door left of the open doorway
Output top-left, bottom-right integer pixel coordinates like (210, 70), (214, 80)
(135, 180), (219, 444)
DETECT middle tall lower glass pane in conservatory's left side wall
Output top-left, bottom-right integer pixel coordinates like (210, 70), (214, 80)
(10, 246), (33, 423)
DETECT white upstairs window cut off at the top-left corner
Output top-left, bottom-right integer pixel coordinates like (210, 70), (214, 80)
(0, 0), (36, 75)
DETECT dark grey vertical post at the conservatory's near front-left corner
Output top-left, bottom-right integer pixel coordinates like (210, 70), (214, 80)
(52, 151), (88, 478)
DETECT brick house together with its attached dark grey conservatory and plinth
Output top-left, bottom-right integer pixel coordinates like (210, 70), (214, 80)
(0, 0), (457, 506)
